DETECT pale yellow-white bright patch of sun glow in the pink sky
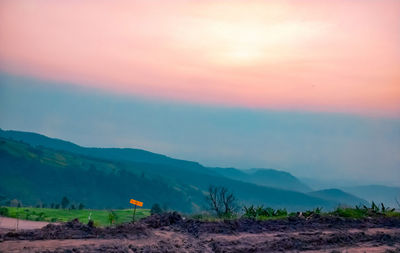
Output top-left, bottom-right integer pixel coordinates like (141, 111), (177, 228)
(177, 17), (327, 66)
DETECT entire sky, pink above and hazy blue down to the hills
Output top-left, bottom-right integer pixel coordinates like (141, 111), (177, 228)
(0, 0), (400, 186)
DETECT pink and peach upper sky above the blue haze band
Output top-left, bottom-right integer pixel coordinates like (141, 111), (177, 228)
(0, 0), (400, 116)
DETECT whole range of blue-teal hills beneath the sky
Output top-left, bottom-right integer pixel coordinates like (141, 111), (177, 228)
(0, 130), (396, 212)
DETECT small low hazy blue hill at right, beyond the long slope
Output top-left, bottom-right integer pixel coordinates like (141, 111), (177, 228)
(308, 189), (368, 206)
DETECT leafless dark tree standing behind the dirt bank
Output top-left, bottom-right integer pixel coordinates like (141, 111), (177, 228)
(207, 185), (236, 217)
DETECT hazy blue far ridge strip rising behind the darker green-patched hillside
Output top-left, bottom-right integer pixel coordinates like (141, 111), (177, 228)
(0, 129), (311, 192)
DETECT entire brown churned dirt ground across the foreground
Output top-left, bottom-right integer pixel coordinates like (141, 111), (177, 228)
(0, 213), (400, 252)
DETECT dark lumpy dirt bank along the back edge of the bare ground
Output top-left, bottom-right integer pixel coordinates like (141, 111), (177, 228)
(2, 212), (400, 240)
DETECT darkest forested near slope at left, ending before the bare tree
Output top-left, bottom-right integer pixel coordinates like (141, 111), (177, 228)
(0, 139), (202, 212)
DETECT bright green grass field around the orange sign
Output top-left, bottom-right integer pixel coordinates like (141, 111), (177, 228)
(1, 207), (150, 226)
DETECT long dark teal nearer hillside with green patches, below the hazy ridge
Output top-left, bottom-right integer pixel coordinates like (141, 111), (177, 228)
(0, 136), (334, 212)
